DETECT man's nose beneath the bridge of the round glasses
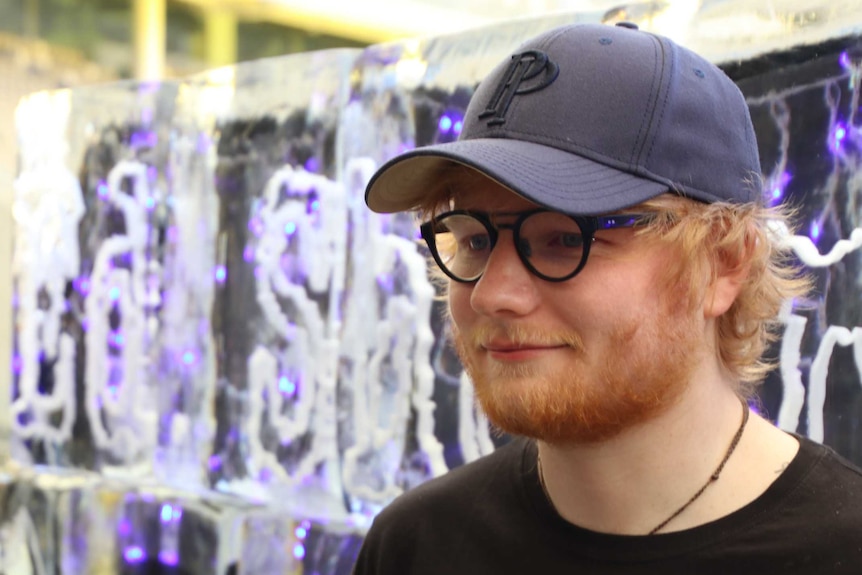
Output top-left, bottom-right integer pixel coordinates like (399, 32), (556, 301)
(470, 232), (539, 317)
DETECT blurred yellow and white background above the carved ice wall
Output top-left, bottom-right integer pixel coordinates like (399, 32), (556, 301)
(0, 0), (612, 457)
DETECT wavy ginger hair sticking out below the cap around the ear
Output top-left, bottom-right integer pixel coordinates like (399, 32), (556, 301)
(632, 193), (811, 396)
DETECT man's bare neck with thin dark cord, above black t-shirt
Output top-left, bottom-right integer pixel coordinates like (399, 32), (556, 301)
(539, 382), (798, 535)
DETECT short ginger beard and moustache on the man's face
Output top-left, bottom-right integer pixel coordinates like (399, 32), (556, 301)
(453, 306), (703, 445)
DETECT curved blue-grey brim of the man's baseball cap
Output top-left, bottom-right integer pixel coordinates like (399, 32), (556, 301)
(365, 138), (669, 215)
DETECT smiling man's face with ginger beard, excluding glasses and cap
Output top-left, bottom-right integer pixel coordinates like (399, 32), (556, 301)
(449, 180), (708, 444)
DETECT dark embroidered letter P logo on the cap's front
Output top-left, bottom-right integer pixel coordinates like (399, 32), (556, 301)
(479, 50), (560, 126)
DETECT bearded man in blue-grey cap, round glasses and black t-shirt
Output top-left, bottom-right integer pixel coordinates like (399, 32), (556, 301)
(355, 20), (862, 575)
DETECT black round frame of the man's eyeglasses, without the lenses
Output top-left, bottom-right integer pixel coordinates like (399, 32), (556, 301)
(419, 208), (655, 283)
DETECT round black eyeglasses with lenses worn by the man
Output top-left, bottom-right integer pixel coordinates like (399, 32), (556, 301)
(419, 209), (653, 283)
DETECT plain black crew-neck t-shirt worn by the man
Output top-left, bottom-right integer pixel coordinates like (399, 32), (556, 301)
(355, 438), (862, 575)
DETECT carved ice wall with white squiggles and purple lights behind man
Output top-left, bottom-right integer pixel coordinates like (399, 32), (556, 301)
(5, 1), (862, 575)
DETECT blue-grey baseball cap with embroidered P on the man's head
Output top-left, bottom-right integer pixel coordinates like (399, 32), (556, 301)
(365, 23), (762, 215)
